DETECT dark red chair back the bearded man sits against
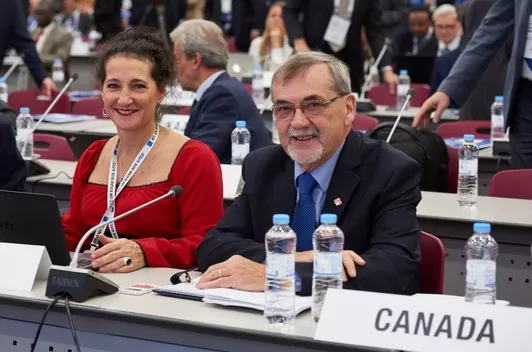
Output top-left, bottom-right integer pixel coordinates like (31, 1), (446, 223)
(419, 231), (445, 294)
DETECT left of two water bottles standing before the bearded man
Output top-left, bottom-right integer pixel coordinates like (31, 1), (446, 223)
(264, 214), (297, 327)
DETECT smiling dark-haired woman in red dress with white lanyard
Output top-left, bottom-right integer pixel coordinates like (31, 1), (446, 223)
(62, 29), (223, 272)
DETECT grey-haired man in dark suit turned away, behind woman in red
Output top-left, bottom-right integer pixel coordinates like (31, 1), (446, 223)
(170, 20), (272, 164)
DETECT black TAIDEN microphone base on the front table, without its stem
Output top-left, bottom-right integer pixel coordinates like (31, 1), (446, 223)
(46, 265), (119, 302)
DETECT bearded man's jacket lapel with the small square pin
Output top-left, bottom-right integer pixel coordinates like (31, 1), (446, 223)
(321, 132), (362, 221)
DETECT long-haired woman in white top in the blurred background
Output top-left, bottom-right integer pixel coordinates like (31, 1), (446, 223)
(249, 1), (293, 71)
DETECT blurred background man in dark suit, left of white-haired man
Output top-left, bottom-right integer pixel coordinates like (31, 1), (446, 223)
(395, 8), (438, 56)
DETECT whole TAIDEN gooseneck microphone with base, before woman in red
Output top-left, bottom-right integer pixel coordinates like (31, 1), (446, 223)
(46, 185), (183, 302)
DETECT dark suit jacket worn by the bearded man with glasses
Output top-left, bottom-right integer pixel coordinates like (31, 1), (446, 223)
(197, 132), (421, 295)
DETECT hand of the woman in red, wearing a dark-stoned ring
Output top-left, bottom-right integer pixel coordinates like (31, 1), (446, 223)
(91, 235), (146, 273)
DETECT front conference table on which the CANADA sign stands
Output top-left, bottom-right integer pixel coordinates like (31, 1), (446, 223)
(0, 268), (382, 352)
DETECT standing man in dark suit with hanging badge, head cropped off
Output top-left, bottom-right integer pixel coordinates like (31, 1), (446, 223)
(283, 0), (397, 93)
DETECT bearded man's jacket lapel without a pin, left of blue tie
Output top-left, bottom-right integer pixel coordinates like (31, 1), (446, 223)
(272, 156), (297, 219)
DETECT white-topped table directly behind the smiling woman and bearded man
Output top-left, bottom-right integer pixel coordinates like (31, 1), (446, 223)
(28, 160), (532, 307)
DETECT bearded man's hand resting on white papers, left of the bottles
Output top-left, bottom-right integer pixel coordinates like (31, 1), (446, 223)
(196, 255), (266, 292)
